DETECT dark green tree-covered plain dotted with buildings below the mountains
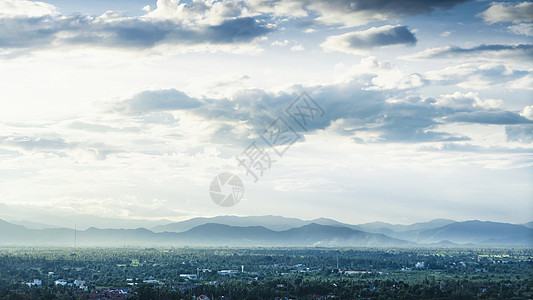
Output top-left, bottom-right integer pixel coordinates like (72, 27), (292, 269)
(0, 248), (533, 299)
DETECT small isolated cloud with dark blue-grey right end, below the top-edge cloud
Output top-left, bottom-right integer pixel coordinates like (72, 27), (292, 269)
(321, 25), (417, 54)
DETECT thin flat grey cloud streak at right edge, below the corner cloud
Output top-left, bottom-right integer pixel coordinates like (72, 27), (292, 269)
(403, 44), (533, 61)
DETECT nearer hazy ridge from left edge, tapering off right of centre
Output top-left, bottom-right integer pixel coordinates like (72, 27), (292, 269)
(0, 221), (409, 247)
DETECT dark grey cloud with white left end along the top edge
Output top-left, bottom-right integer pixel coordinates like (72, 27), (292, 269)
(179, 0), (468, 27)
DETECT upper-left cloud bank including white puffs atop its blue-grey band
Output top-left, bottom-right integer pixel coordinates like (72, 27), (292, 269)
(0, 4), (274, 57)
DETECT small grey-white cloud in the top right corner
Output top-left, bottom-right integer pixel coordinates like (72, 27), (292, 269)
(478, 1), (533, 24)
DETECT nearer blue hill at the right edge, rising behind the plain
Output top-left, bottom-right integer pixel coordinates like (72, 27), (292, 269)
(416, 221), (533, 247)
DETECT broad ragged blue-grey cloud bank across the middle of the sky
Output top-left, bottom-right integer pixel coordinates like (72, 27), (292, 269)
(112, 85), (532, 143)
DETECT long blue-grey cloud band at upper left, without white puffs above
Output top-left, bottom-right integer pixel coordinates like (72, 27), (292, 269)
(0, 15), (272, 49)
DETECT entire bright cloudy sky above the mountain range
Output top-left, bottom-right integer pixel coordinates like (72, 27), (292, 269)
(0, 0), (533, 225)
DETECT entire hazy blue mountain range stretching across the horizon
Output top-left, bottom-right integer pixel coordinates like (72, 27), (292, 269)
(0, 216), (533, 247)
